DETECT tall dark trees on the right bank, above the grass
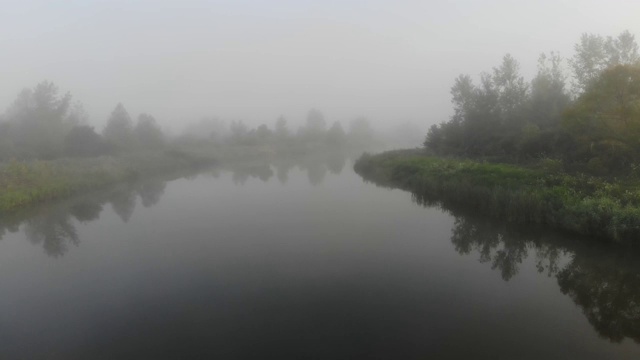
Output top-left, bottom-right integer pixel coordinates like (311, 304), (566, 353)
(424, 31), (640, 174)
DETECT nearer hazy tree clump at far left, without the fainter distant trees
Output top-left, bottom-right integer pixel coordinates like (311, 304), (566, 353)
(0, 81), (166, 160)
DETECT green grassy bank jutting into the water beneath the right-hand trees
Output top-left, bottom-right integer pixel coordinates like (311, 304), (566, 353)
(354, 151), (640, 242)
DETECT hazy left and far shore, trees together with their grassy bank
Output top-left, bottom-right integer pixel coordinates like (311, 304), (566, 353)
(0, 77), (374, 213)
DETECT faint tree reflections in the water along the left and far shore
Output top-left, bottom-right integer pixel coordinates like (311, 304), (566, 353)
(0, 152), (347, 257)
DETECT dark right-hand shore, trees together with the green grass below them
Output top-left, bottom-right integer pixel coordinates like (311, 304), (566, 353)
(355, 31), (640, 242)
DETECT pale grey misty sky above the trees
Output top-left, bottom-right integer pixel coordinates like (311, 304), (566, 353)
(0, 0), (640, 129)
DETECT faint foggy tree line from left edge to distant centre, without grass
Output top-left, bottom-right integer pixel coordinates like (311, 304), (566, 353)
(0, 81), (376, 161)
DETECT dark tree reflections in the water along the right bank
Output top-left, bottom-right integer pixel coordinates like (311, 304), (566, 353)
(368, 176), (640, 343)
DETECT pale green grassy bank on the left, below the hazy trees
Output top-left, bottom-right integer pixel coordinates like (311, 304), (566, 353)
(0, 150), (214, 213)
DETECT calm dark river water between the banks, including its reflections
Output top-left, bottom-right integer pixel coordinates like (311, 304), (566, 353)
(0, 160), (640, 359)
